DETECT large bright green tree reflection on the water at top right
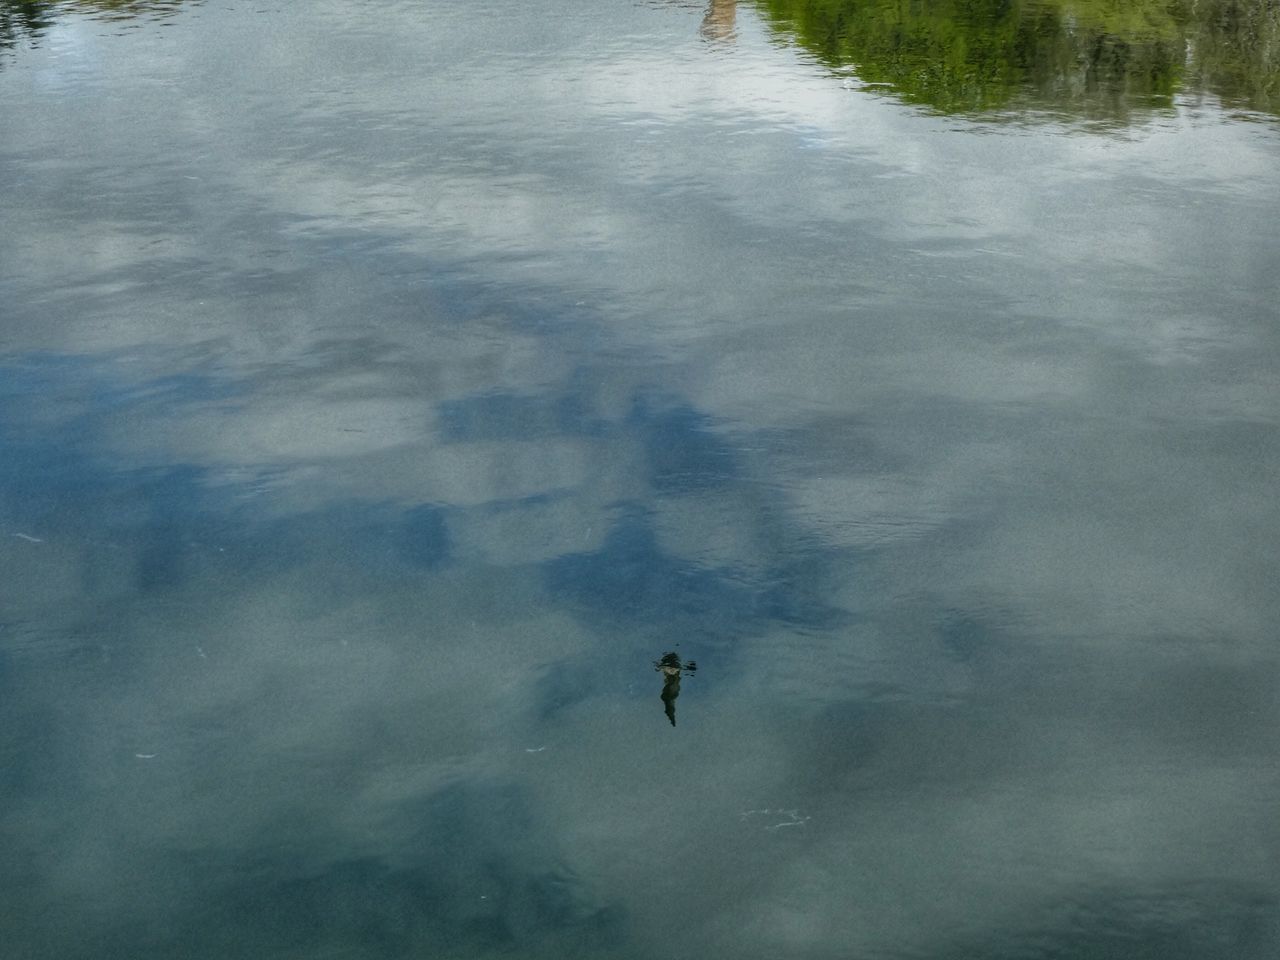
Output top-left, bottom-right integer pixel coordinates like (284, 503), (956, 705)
(756, 0), (1280, 120)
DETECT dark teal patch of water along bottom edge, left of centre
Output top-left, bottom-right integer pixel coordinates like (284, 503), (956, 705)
(171, 781), (622, 957)
